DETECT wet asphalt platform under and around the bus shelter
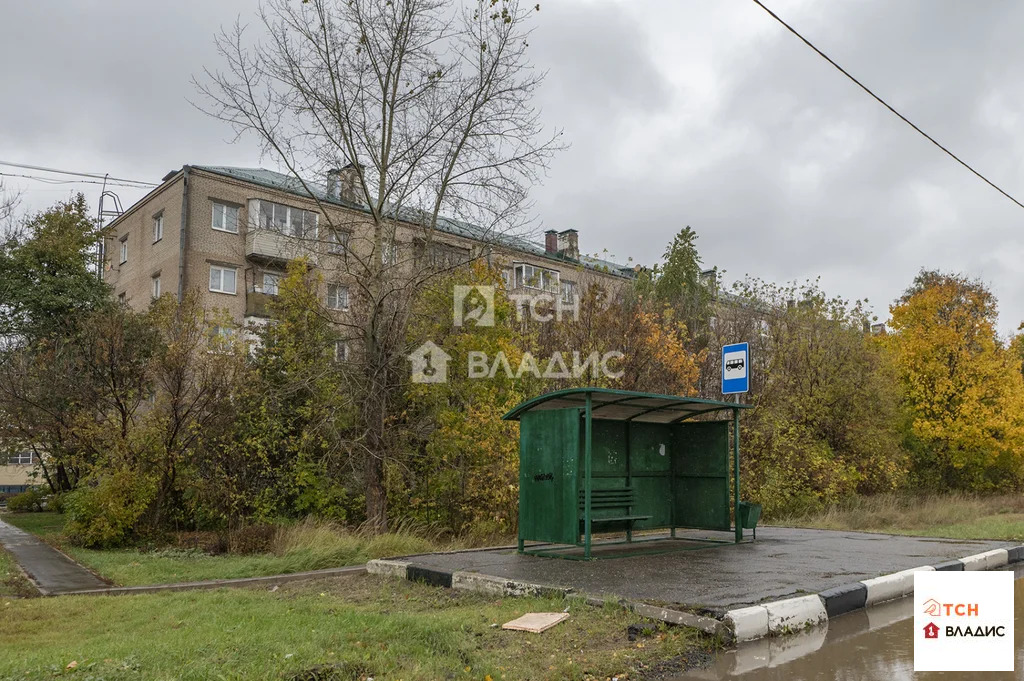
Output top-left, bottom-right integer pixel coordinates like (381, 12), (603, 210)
(401, 527), (1008, 616)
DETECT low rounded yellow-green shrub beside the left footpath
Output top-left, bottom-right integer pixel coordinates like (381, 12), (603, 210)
(65, 470), (157, 548)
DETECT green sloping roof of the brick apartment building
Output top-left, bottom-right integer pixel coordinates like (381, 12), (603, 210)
(191, 166), (634, 279)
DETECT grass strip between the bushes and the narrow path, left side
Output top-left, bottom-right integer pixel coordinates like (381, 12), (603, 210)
(2, 512), (437, 586)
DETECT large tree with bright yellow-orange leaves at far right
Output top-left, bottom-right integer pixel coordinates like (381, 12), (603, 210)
(886, 270), (1024, 491)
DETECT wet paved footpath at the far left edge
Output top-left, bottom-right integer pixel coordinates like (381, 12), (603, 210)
(0, 520), (110, 596)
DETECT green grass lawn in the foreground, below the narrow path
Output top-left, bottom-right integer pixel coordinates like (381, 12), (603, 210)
(0, 574), (714, 681)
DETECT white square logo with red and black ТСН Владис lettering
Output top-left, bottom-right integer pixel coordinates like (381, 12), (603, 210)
(913, 571), (1014, 672)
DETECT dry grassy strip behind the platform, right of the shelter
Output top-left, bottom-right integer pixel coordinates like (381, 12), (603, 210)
(775, 494), (1024, 541)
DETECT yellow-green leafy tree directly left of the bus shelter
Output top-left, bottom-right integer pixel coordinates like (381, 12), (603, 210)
(399, 262), (540, 540)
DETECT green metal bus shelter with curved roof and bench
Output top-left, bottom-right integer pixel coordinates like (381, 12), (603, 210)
(503, 388), (757, 559)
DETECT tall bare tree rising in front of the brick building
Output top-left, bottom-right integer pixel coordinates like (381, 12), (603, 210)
(197, 0), (561, 530)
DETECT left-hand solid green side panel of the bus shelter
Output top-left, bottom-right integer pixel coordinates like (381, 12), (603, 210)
(519, 408), (581, 544)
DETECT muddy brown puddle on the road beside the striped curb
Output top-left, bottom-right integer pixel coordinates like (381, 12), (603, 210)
(677, 566), (1024, 681)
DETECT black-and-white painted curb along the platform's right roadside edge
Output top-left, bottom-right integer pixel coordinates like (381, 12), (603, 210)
(723, 546), (1024, 641)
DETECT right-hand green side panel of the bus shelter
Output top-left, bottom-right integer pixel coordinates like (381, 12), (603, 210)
(673, 421), (731, 530)
